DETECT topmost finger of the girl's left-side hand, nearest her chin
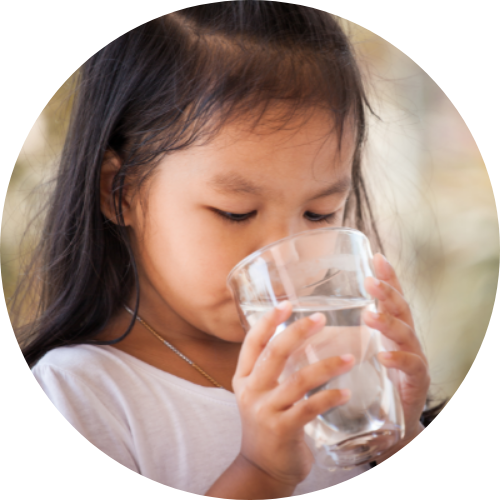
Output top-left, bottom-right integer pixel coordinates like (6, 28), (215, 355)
(234, 300), (292, 379)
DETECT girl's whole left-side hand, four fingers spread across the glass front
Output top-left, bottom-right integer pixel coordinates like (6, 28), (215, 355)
(233, 302), (354, 490)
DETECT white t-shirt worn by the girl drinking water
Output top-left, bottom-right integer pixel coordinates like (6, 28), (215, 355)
(33, 345), (368, 495)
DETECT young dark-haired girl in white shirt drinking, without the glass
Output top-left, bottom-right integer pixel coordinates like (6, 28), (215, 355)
(15, 1), (429, 498)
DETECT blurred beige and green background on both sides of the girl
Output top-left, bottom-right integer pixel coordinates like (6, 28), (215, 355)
(1, 17), (499, 400)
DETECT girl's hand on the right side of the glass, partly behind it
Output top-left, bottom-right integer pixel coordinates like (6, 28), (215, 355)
(364, 254), (430, 444)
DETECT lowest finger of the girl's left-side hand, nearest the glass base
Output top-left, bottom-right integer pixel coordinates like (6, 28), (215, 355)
(281, 389), (351, 431)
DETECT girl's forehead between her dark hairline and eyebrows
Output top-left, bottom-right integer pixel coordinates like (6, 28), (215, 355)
(156, 107), (356, 189)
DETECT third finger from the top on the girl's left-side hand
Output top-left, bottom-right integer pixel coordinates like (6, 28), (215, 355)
(271, 354), (354, 411)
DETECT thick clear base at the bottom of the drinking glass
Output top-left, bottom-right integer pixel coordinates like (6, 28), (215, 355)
(318, 430), (401, 468)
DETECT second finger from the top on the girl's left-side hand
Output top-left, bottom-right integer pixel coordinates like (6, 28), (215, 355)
(248, 313), (326, 391)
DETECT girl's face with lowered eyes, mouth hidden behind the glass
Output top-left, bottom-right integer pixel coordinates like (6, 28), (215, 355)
(126, 112), (354, 342)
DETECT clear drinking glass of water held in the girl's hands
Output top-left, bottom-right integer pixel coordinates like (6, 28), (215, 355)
(228, 228), (404, 469)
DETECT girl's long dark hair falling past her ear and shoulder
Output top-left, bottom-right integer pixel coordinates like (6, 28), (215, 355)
(13, 1), (378, 366)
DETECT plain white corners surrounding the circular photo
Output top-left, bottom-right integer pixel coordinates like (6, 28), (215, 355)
(0, 0), (500, 500)
